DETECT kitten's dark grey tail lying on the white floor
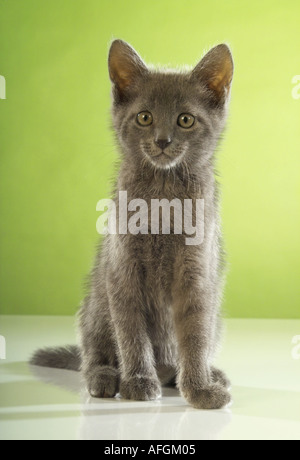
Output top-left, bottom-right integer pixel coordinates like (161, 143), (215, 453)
(30, 345), (81, 371)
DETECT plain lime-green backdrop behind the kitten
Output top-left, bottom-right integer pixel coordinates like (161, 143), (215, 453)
(0, 0), (300, 318)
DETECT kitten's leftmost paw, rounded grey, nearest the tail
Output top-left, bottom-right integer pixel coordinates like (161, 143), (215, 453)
(86, 366), (120, 398)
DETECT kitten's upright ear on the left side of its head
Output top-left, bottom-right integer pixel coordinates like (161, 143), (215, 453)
(108, 40), (148, 100)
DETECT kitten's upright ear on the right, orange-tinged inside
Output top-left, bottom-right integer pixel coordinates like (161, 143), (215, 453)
(191, 44), (234, 104)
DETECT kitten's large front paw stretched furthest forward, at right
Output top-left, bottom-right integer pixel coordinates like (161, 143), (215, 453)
(181, 383), (231, 410)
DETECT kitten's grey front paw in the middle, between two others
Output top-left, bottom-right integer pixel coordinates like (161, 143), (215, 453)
(120, 377), (161, 401)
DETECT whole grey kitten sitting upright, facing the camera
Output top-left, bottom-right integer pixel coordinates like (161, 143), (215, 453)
(31, 40), (233, 409)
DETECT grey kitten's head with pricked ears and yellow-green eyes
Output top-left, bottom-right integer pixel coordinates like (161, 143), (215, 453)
(109, 40), (233, 169)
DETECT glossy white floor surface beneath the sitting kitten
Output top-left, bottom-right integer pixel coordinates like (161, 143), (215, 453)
(0, 316), (300, 440)
